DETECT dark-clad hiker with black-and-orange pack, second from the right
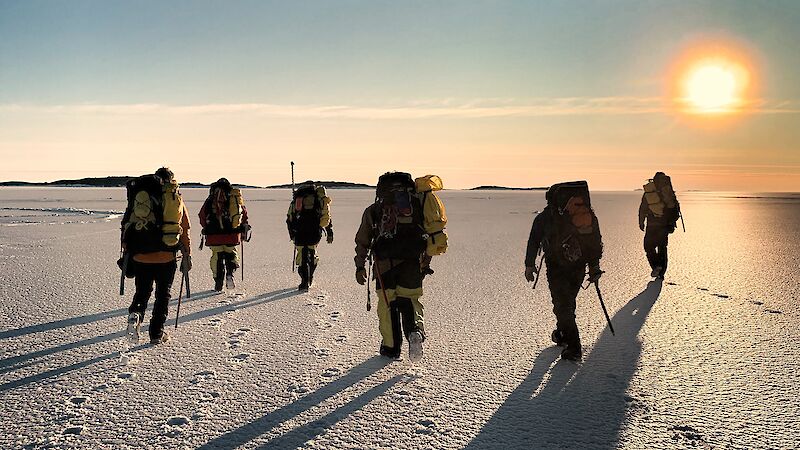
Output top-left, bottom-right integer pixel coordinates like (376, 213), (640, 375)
(525, 181), (603, 361)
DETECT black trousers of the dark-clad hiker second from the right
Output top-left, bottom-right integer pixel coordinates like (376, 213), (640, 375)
(547, 263), (586, 348)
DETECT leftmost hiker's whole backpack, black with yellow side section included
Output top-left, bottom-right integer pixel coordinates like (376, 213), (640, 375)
(122, 175), (183, 255)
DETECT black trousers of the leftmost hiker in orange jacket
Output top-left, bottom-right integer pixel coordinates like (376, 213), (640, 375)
(128, 261), (178, 338)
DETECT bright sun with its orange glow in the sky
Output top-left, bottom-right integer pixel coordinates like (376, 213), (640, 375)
(669, 42), (755, 117)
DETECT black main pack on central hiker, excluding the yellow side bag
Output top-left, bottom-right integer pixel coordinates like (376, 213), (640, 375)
(372, 172), (428, 260)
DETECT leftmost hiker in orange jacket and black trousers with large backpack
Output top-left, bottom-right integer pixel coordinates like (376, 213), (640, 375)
(121, 167), (192, 344)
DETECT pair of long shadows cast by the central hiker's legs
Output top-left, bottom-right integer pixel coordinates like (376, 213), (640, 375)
(198, 356), (402, 450)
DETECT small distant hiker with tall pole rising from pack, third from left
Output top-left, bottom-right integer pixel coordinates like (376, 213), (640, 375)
(286, 180), (333, 292)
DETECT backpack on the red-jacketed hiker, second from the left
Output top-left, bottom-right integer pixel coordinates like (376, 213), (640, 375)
(203, 178), (244, 235)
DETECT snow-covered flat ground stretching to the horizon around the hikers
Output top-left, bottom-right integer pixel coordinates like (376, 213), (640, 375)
(0, 188), (800, 449)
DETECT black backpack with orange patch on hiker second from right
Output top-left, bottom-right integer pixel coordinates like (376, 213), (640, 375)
(545, 181), (603, 265)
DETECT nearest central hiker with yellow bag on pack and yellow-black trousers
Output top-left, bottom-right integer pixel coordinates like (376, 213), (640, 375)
(355, 172), (447, 362)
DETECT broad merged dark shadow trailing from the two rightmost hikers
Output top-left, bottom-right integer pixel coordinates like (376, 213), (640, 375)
(466, 280), (662, 450)
